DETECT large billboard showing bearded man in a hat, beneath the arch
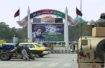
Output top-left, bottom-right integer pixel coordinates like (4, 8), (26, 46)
(32, 23), (64, 42)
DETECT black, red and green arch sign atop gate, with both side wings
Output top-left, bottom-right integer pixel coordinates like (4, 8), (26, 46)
(17, 9), (78, 26)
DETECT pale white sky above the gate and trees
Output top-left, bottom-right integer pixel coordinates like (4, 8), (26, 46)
(0, 0), (105, 28)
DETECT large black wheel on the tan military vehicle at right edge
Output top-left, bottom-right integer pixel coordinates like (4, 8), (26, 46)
(96, 39), (105, 61)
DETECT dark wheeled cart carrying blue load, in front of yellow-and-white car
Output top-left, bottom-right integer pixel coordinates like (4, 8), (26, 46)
(0, 43), (37, 60)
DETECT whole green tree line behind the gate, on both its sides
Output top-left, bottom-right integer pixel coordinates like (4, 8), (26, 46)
(0, 22), (91, 40)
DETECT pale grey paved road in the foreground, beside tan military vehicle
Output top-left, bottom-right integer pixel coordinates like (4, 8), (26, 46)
(0, 54), (78, 68)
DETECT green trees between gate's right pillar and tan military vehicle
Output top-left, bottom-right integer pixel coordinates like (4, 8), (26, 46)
(69, 22), (91, 40)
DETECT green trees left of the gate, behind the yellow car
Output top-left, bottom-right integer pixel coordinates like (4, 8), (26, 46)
(0, 22), (27, 40)
